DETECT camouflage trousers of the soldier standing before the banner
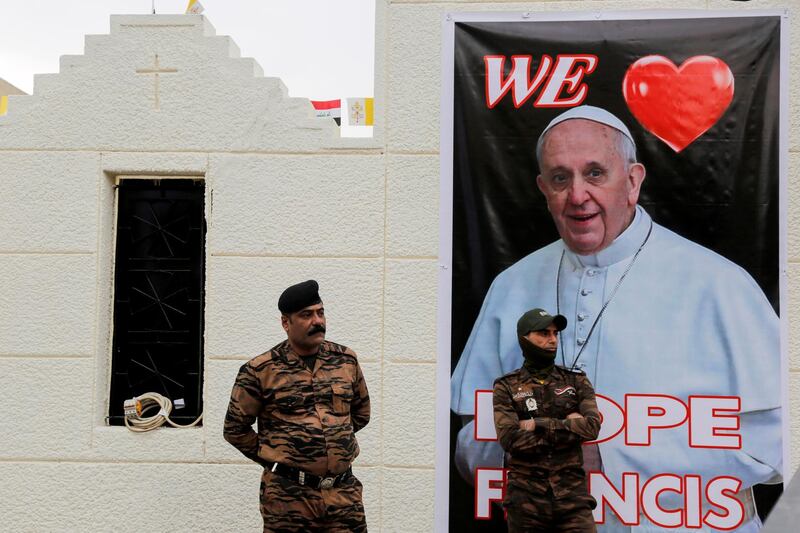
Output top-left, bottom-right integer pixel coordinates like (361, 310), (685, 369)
(503, 468), (597, 533)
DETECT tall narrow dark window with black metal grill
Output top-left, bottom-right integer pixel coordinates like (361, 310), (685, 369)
(109, 179), (205, 425)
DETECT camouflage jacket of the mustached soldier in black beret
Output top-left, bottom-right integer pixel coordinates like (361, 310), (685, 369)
(223, 341), (370, 476)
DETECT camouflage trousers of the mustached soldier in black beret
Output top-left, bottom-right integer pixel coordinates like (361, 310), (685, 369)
(261, 469), (367, 533)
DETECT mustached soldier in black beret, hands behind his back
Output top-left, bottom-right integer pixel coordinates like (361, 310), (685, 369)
(224, 280), (370, 533)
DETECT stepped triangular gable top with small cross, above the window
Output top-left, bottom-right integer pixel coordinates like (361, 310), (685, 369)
(0, 15), (356, 152)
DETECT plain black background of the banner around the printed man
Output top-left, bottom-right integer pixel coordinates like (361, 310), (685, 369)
(449, 16), (780, 531)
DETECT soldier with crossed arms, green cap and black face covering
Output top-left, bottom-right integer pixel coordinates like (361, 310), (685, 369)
(494, 309), (600, 533)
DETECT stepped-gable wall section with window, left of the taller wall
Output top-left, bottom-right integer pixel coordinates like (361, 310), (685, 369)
(0, 16), (384, 532)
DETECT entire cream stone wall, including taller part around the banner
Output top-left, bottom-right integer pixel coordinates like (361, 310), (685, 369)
(0, 0), (800, 533)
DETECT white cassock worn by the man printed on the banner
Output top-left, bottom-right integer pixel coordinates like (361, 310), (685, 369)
(451, 206), (782, 531)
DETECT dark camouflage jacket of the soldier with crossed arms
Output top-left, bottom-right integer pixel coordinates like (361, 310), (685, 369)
(493, 366), (600, 475)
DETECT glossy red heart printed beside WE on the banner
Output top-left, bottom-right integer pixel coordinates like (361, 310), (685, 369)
(622, 56), (733, 152)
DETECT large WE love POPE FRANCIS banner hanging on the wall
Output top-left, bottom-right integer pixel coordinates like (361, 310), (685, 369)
(437, 11), (787, 531)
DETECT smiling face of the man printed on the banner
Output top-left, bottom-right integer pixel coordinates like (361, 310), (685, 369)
(536, 119), (645, 255)
